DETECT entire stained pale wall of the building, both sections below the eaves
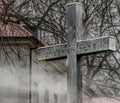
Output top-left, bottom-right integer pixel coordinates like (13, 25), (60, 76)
(0, 45), (67, 103)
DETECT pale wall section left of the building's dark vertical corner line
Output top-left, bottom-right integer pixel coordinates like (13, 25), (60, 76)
(0, 46), (29, 103)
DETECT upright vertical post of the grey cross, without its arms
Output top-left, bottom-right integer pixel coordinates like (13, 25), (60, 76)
(66, 2), (82, 103)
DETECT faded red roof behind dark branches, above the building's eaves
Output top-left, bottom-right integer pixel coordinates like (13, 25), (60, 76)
(0, 0), (33, 37)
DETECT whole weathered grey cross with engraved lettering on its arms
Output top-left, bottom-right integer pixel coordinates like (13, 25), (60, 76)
(38, 2), (116, 103)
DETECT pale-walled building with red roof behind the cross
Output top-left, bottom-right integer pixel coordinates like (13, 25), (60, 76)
(0, 21), (67, 103)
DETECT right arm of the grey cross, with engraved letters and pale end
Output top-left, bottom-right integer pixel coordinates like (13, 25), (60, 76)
(77, 36), (116, 55)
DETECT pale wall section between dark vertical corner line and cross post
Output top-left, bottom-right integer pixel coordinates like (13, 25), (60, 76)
(32, 49), (67, 103)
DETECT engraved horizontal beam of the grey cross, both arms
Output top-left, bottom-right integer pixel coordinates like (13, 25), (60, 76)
(38, 36), (116, 60)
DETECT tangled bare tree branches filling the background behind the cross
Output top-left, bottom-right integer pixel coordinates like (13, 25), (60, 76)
(0, 0), (120, 96)
